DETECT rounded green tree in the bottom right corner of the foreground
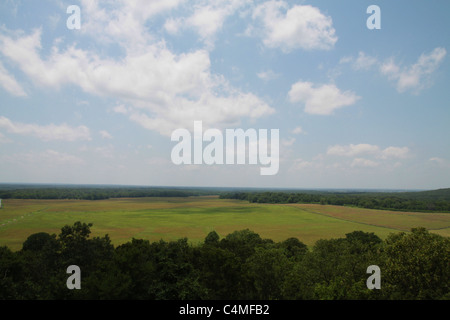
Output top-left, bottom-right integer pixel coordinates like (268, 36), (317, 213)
(380, 228), (450, 300)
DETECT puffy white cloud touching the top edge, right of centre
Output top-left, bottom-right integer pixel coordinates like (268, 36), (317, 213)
(248, 1), (338, 53)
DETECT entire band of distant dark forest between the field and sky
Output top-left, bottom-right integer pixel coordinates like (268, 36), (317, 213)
(0, 184), (450, 212)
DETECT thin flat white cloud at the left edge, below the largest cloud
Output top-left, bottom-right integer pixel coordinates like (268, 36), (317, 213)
(0, 116), (91, 142)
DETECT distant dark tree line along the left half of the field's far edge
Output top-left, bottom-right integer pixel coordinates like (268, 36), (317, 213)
(0, 187), (208, 200)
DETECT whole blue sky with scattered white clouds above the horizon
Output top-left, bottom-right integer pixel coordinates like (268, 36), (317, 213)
(0, 0), (450, 189)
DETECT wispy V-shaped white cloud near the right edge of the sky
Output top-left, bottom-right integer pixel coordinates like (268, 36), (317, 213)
(380, 47), (447, 93)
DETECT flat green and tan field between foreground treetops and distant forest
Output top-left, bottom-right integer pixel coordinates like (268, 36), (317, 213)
(0, 196), (450, 250)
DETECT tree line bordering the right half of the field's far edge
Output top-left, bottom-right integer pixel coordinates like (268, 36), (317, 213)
(220, 192), (450, 212)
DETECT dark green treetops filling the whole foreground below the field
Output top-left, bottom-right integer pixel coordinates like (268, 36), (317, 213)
(0, 222), (450, 300)
